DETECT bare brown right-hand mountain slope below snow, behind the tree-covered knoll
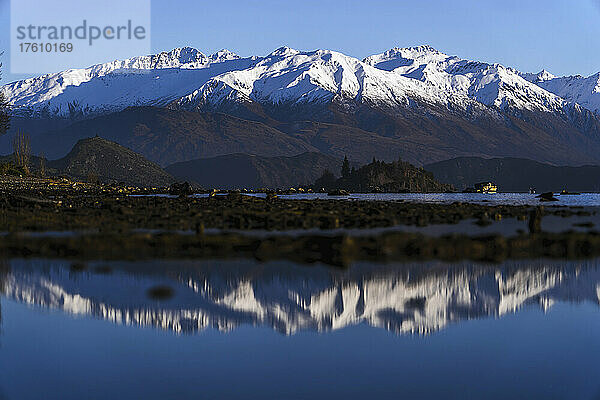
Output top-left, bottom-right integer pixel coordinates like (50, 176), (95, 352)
(191, 101), (600, 165)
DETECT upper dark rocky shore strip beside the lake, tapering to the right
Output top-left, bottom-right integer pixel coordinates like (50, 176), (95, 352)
(0, 188), (591, 233)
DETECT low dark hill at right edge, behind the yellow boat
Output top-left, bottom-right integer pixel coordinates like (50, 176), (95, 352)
(424, 157), (600, 192)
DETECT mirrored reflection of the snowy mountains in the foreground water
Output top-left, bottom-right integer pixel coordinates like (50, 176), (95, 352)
(0, 261), (600, 334)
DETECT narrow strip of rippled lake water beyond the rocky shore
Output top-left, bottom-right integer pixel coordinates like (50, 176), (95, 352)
(195, 193), (600, 207)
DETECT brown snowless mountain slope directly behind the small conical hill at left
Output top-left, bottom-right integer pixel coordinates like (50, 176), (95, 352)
(18, 107), (315, 165)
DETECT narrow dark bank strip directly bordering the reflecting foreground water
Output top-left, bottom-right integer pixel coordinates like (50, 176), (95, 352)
(0, 228), (600, 267)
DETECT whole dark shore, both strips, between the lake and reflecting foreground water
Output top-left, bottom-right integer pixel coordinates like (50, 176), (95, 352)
(0, 182), (600, 266)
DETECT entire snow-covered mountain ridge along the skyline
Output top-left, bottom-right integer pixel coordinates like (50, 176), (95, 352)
(2, 46), (594, 119)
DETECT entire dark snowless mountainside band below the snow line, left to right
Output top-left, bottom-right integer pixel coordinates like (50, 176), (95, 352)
(7, 97), (600, 170)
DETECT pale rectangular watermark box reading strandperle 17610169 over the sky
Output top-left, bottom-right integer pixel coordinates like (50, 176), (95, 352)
(10, 0), (150, 73)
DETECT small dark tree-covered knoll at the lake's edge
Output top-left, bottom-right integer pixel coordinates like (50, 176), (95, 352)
(313, 160), (454, 193)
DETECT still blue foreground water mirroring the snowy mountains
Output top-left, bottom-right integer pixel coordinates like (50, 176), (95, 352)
(0, 260), (600, 399)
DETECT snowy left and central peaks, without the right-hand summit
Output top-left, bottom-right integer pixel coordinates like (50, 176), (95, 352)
(2, 47), (492, 115)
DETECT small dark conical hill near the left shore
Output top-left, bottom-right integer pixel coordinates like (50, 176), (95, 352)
(48, 137), (175, 187)
